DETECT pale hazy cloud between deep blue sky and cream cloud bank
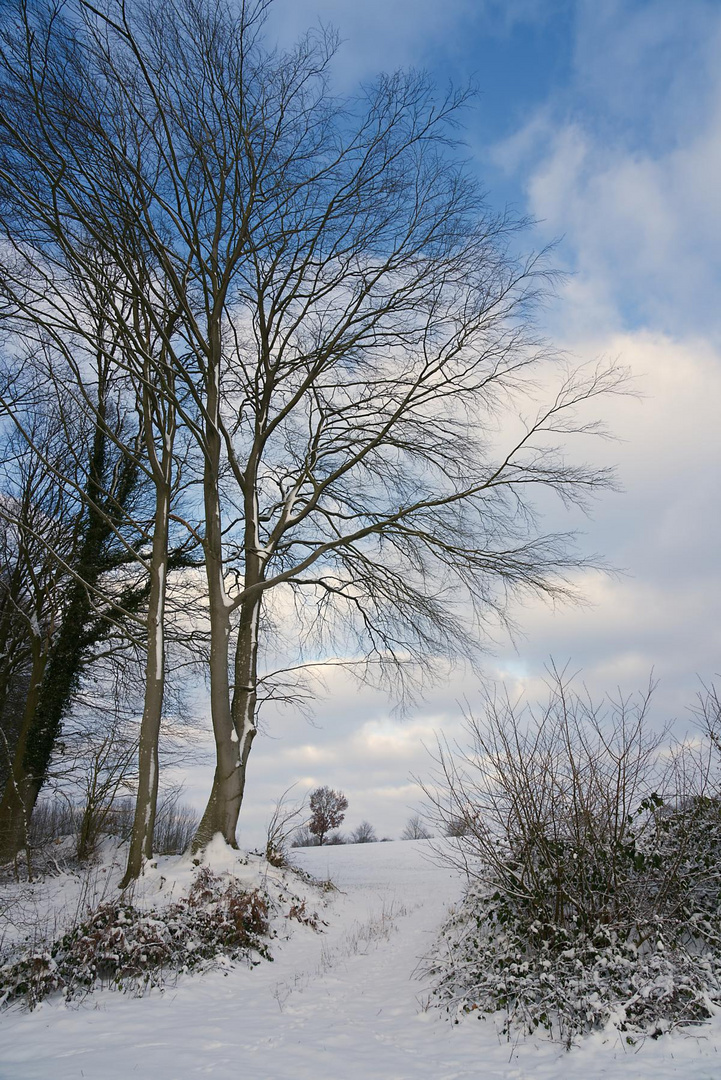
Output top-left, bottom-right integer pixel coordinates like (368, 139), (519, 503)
(528, 122), (721, 332)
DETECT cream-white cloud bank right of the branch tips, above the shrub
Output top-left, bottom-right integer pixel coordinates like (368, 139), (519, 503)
(492, 332), (721, 718)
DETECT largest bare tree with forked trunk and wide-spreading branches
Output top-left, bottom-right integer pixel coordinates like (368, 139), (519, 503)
(0, 0), (618, 873)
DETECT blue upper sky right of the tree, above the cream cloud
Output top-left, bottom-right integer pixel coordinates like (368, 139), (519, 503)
(271, 0), (721, 332)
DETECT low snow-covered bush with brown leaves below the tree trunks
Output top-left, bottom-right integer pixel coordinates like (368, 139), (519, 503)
(0, 866), (271, 1008)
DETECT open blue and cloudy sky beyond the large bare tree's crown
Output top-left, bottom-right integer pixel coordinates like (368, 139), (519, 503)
(180, 0), (721, 845)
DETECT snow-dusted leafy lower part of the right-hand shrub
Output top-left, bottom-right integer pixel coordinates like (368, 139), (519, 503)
(434, 876), (721, 1047)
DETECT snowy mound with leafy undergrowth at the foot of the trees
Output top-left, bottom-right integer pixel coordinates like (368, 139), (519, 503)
(0, 837), (323, 1008)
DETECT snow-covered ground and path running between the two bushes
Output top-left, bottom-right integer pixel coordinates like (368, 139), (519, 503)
(0, 840), (721, 1080)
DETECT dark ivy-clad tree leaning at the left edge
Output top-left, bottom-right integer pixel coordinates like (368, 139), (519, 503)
(0, 354), (201, 861)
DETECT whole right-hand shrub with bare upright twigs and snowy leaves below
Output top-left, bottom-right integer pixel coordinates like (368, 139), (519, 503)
(426, 673), (721, 1045)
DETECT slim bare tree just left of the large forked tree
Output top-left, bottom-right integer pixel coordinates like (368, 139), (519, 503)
(0, 159), (195, 877)
